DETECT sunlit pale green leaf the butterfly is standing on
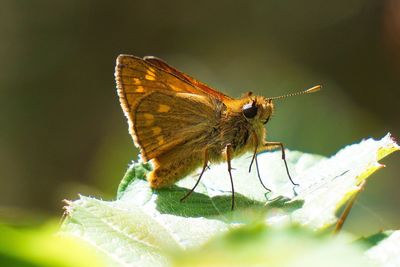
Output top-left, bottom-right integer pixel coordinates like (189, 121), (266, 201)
(63, 135), (399, 266)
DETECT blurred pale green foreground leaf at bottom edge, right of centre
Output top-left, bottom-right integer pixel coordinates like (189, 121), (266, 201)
(172, 224), (375, 267)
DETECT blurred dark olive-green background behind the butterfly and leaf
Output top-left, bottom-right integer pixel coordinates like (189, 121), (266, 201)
(0, 0), (400, 234)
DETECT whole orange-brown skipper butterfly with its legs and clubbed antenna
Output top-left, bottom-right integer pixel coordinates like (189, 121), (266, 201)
(115, 55), (320, 209)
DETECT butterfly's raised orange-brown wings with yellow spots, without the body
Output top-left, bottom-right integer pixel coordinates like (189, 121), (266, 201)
(115, 55), (221, 161)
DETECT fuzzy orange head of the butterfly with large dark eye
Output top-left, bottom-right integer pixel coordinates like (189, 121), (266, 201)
(242, 96), (274, 124)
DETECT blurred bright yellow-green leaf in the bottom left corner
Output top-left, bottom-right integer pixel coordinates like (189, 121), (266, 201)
(0, 225), (105, 267)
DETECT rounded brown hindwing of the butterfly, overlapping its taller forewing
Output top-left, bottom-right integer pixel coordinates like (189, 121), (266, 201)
(129, 91), (216, 160)
